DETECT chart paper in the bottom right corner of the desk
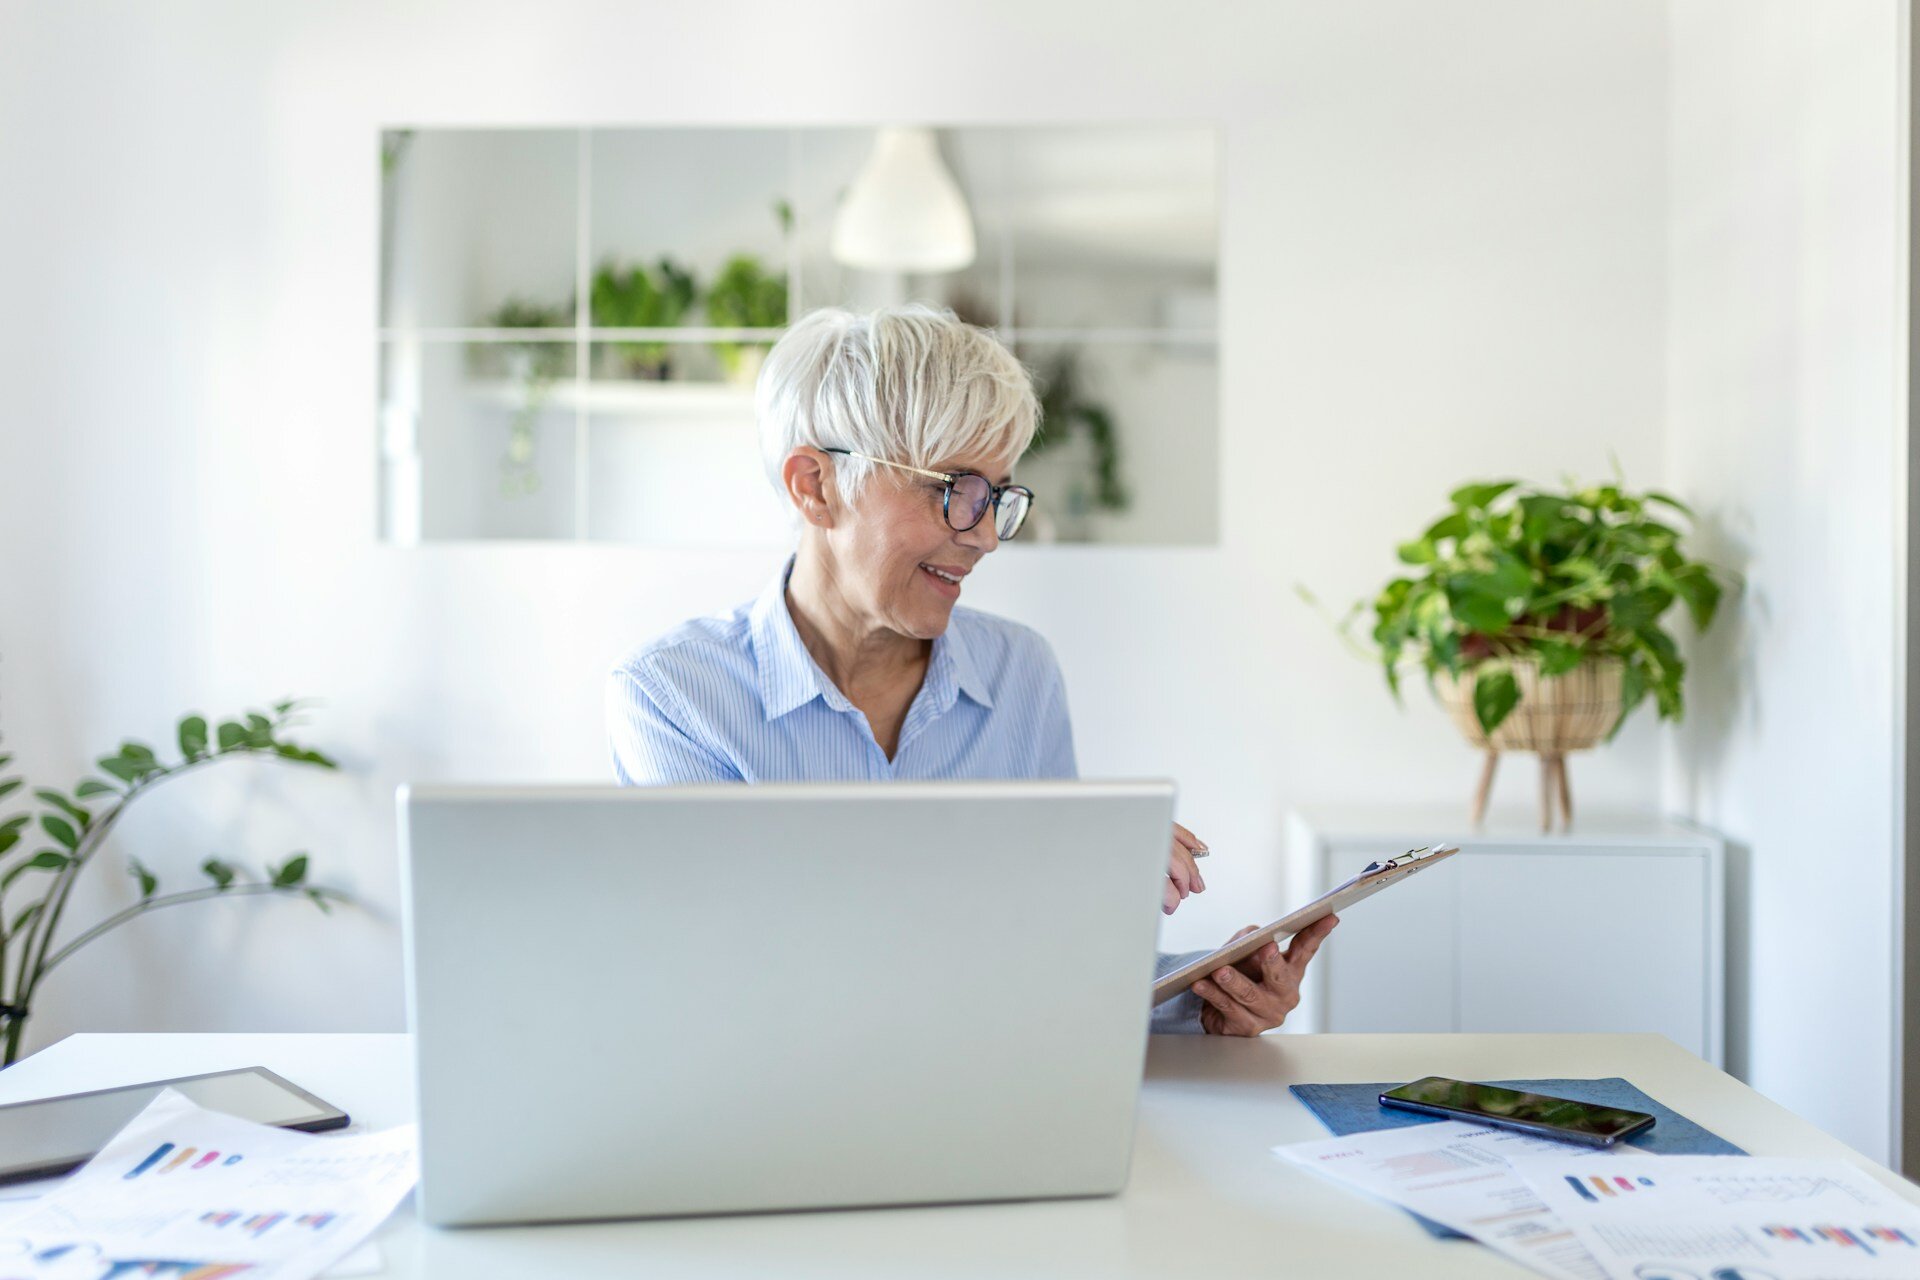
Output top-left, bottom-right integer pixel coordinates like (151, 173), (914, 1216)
(1513, 1155), (1920, 1280)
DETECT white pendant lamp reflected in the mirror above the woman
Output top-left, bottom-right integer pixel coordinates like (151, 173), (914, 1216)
(831, 129), (973, 273)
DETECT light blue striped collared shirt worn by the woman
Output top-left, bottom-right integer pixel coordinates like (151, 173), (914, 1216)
(607, 557), (1200, 1032)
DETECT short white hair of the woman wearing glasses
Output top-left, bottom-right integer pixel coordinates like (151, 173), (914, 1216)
(755, 303), (1041, 497)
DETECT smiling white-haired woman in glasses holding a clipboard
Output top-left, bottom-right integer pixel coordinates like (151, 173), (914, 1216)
(607, 305), (1336, 1036)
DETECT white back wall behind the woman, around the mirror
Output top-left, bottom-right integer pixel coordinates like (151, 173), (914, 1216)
(0, 0), (1667, 1044)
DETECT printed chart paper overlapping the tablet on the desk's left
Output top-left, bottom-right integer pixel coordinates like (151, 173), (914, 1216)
(0, 1088), (417, 1280)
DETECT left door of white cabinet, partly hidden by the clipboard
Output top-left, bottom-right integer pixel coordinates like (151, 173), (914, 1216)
(1313, 844), (1461, 1031)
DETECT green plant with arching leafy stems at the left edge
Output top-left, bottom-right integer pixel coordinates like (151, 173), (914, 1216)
(0, 700), (349, 1067)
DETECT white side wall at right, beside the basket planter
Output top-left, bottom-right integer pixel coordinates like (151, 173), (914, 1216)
(1667, 0), (1907, 1157)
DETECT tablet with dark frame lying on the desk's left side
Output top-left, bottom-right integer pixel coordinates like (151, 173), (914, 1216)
(0, 1067), (349, 1184)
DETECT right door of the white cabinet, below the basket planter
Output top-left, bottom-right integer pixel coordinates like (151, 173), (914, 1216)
(1451, 852), (1709, 1055)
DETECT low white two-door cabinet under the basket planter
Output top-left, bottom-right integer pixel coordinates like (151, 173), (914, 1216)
(1286, 806), (1726, 1065)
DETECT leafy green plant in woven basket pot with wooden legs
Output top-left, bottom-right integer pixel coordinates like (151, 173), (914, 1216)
(1348, 480), (1732, 829)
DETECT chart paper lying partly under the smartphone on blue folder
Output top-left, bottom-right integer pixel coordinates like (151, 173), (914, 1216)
(1273, 1121), (1620, 1280)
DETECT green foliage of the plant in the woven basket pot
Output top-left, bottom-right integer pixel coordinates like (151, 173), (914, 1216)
(1328, 480), (1734, 733)
